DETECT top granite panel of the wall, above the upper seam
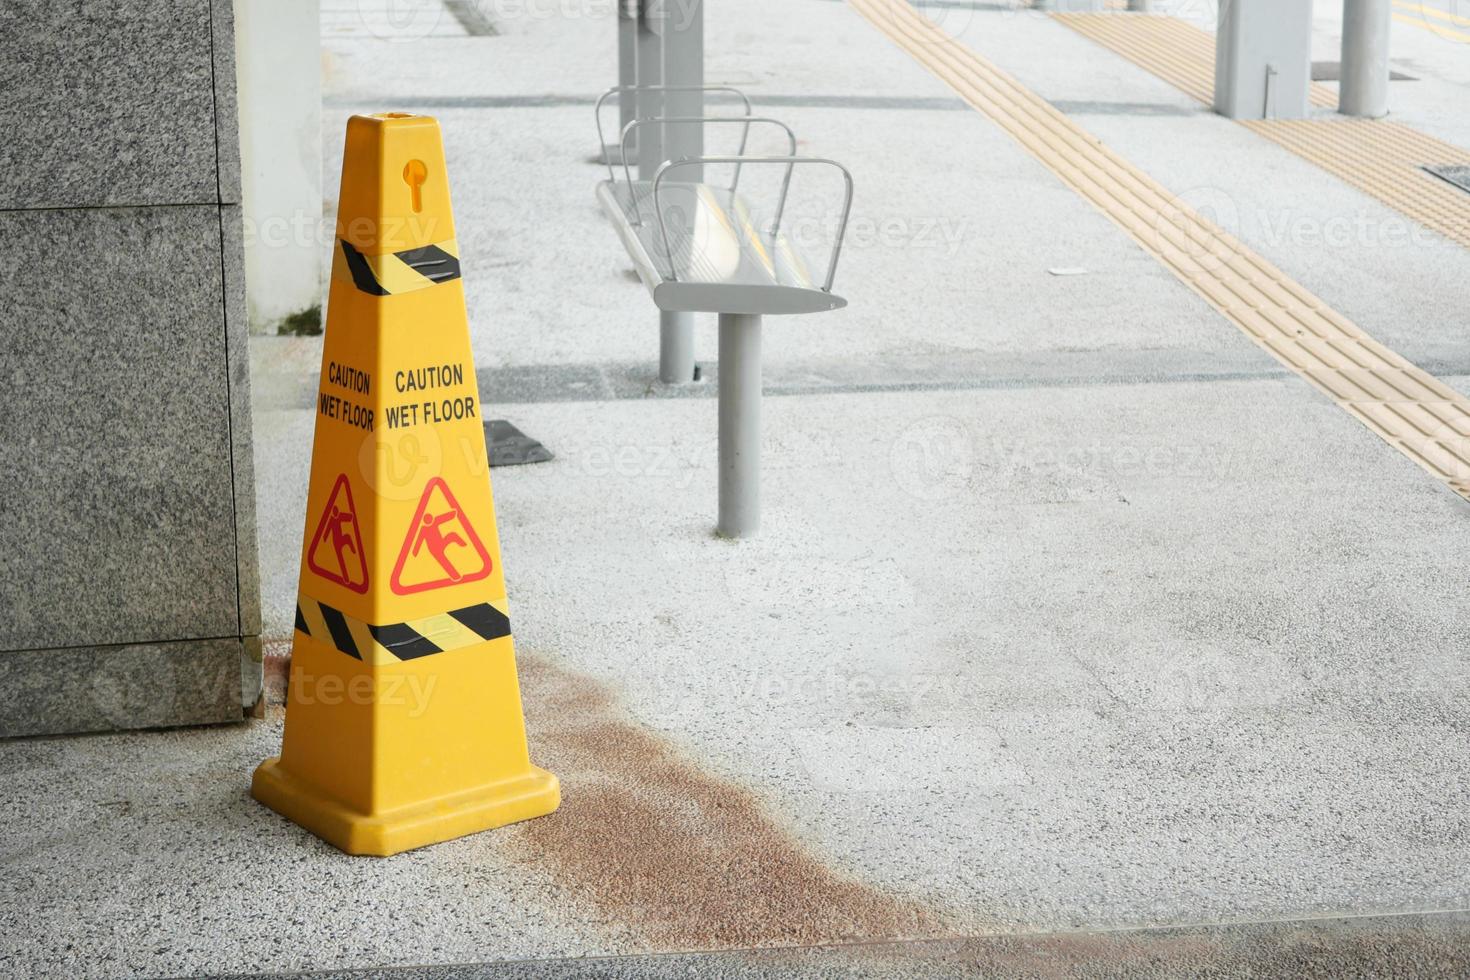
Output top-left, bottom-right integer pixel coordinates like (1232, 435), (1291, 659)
(0, 0), (220, 209)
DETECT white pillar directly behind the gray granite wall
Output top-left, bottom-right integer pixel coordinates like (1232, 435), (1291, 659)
(235, 0), (325, 334)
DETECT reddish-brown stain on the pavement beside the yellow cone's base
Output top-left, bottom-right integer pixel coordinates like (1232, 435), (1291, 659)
(517, 654), (944, 949)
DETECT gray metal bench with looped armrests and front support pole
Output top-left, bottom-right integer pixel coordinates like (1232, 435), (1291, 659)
(597, 87), (853, 538)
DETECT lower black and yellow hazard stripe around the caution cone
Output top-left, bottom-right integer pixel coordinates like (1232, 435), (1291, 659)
(295, 595), (510, 664)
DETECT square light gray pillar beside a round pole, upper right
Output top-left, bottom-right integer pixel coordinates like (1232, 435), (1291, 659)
(1214, 0), (1311, 119)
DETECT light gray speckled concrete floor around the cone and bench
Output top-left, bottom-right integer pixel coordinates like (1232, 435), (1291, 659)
(0, 0), (1470, 977)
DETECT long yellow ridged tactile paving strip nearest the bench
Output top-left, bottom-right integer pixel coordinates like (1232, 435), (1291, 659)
(848, 0), (1470, 498)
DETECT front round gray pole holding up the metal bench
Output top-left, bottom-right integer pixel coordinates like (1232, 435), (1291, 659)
(716, 313), (760, 538)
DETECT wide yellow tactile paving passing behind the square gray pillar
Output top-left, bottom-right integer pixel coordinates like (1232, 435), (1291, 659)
(1053, 13), (1470, 248)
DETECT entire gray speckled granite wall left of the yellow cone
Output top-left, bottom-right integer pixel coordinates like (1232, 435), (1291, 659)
(0, 0), (260, 736)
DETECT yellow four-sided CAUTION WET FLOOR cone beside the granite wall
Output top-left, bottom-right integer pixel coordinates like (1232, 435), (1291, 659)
(251, 113), (560, 855)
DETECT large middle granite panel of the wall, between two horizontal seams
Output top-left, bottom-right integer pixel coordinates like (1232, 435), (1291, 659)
(0, 207), (248, 649)
